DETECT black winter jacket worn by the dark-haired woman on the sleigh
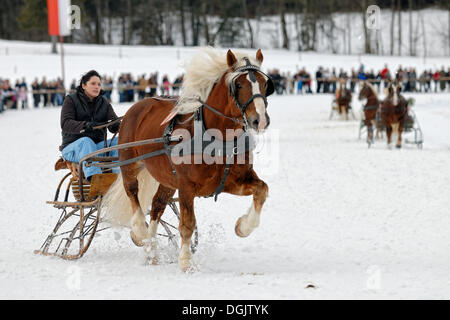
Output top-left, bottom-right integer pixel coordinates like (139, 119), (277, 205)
(59, 87), (120, 150)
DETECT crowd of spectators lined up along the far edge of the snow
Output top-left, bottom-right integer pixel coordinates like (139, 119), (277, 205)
(0, 65), (450, 113)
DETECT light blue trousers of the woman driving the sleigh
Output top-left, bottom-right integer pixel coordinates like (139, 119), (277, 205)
(62, 137), (120, 178)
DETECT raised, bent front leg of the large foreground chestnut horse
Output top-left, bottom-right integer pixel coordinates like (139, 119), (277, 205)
(225, 169), (269, 238)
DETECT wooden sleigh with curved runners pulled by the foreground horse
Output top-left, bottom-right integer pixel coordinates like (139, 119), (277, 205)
(34, 122), (198, 260)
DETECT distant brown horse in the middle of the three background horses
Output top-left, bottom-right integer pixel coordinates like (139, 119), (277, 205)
(358, 81), (380, 147)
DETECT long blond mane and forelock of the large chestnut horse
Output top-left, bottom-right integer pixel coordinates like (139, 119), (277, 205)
(175, 47), (261, 114)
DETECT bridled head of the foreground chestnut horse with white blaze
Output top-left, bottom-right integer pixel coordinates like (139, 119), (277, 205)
(227, 50), (274, 132)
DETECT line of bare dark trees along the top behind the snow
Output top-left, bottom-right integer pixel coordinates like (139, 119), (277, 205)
(0, 0), (450, 55)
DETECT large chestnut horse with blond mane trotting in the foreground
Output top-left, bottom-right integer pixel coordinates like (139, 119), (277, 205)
(104, 48), (274, 272)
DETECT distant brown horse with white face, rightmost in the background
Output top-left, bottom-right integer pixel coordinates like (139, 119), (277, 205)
(381, 83), (409, 148)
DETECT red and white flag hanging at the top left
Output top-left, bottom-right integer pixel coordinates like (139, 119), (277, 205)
(47, 0), (72, 36)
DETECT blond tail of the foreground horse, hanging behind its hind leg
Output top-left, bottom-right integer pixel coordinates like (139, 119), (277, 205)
(101, 168), (159, 227)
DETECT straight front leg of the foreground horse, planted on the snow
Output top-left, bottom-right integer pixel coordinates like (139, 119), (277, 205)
(178, 188), (195, 272)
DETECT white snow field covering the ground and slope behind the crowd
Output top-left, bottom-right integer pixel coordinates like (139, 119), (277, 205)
(0, 41), (450, 300)
